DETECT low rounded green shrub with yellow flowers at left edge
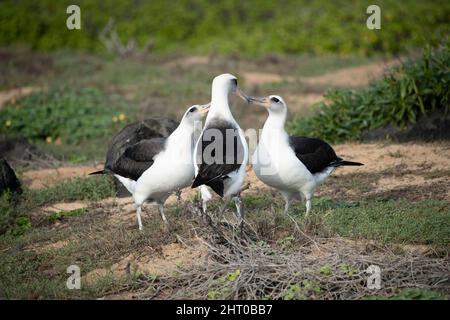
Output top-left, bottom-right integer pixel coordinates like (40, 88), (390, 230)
(0, 89), (132, 144)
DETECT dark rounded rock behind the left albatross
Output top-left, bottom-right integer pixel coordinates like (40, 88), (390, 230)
(105, 118), (178, 196)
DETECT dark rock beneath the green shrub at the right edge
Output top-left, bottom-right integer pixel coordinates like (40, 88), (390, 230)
(361, 109), (450, 142)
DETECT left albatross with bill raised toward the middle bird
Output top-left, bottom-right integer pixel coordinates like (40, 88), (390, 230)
(91, 103), (210, 230)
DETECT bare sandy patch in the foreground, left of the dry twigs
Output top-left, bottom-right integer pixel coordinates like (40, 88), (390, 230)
(85, 243), (207, 283)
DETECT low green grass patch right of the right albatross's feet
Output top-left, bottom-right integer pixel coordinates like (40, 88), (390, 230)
(318, 200), (450, 246)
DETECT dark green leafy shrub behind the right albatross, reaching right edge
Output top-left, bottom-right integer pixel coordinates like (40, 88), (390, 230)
(290, 42), (450, 142)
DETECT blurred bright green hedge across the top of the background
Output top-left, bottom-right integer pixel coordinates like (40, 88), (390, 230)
(0, 0), (450, 56)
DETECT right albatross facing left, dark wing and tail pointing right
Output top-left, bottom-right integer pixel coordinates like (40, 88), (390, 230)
(248, 95), (363, 214)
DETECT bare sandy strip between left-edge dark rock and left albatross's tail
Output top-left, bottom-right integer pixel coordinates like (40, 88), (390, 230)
(21, 165), (103, 189)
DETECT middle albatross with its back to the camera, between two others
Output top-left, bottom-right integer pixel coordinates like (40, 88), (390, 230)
(192, 74), (248, 219)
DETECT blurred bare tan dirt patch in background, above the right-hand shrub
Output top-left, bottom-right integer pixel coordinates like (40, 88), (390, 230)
(302, 61), (399, 87)
